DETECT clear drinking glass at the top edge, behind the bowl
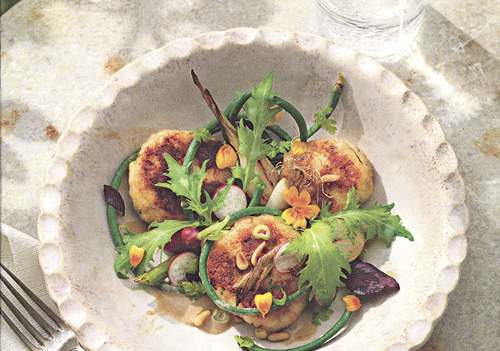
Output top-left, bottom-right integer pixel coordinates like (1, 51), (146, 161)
(317, 0), (425, 60)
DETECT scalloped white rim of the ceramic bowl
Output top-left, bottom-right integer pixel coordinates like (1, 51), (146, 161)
(38, 28), (469, 350)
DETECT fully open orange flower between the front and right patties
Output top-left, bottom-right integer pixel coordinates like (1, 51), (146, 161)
(281, 186), (320, 229)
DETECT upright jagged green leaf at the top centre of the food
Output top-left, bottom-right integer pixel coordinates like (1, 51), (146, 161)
(233, 72), (282, 192)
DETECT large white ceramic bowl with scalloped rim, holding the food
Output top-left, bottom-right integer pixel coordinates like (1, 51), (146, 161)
(38, 28), (468, 351)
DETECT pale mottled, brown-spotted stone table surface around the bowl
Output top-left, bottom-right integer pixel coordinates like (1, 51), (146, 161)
(0, 0), (500, 351)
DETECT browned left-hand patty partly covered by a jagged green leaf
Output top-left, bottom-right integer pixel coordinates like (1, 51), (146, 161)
(129, 130), (231, 223)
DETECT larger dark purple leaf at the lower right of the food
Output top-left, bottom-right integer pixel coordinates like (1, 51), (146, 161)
(340, 260), (399, 296)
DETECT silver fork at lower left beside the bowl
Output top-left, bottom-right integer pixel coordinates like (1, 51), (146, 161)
(0, 262), (83, 351)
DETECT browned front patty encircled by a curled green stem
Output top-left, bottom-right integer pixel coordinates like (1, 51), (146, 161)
(207, 215), (308, 332)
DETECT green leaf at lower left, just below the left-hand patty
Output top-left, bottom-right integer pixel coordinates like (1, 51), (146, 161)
(114, 220), (200, 279)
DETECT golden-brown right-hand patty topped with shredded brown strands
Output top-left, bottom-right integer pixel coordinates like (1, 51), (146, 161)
(281, 137), (373, 213)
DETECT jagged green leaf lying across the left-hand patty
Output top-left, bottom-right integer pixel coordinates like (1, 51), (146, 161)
(156, 153), (231, 226)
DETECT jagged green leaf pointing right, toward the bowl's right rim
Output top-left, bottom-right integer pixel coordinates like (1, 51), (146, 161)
(320, 187), (414, 247)
